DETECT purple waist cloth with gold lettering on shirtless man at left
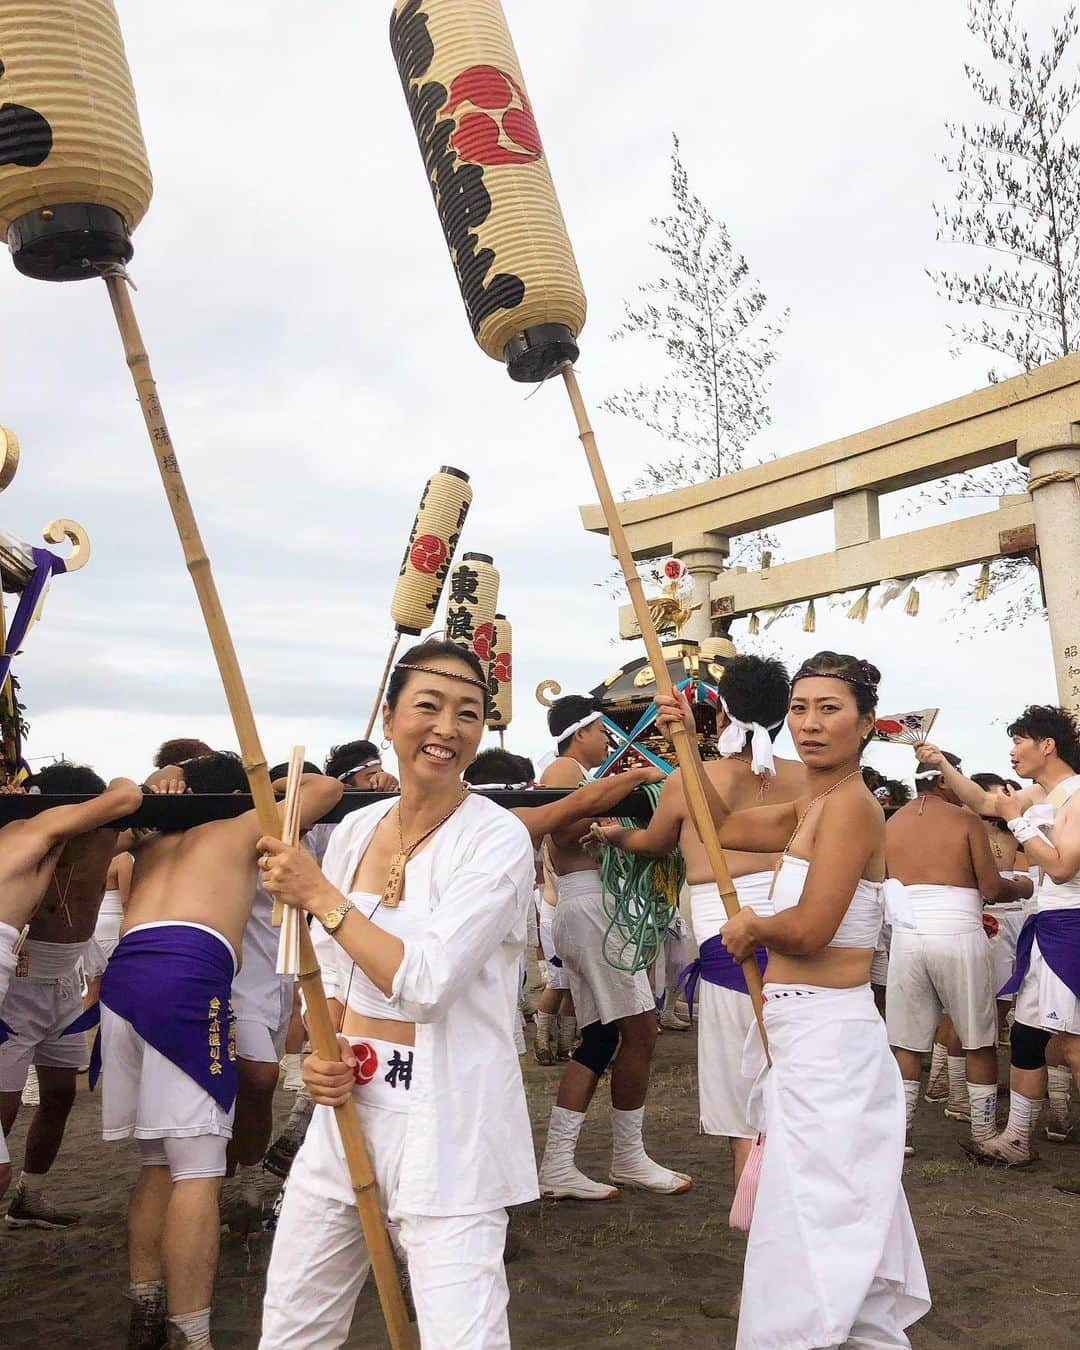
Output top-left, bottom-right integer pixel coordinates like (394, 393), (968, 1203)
(101, 923), (236, 1111)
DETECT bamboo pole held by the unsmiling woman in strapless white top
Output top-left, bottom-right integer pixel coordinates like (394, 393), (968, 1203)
(562, 363), (768, 1054)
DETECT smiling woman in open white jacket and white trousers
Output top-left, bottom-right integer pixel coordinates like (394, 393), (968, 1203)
(259, 641), (539, 1350)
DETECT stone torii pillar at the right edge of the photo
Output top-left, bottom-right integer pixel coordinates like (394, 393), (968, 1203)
(1017, 423), (1080, 714)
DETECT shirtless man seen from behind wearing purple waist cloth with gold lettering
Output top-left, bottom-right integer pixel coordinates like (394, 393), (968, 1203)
(101, 753), (342, 1350)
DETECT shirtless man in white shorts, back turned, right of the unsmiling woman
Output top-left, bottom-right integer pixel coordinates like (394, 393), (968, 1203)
(886, 756), (1031, 1156)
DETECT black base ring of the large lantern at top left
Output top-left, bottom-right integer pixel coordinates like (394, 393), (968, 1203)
(8, 201), (135, 281)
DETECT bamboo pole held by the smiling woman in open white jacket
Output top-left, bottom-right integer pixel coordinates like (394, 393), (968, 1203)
(105, 271), (416, 1350)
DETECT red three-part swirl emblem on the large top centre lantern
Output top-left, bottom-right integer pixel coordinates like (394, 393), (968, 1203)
(439, 66), (544, 165)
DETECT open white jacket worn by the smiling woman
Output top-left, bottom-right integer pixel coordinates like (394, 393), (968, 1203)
(319, 797), (539, 1216)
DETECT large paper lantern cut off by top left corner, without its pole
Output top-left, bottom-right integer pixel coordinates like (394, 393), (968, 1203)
(0, 0), (153, 281)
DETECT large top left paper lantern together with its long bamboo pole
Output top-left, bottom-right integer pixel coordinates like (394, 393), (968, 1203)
(0, 0), (413, 1350)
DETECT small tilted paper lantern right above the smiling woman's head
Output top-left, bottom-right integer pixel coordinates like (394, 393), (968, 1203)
(390, 464), (473, 636)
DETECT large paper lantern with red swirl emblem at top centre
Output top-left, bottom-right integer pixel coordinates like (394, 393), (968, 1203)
(390, 0), (585, 382)
